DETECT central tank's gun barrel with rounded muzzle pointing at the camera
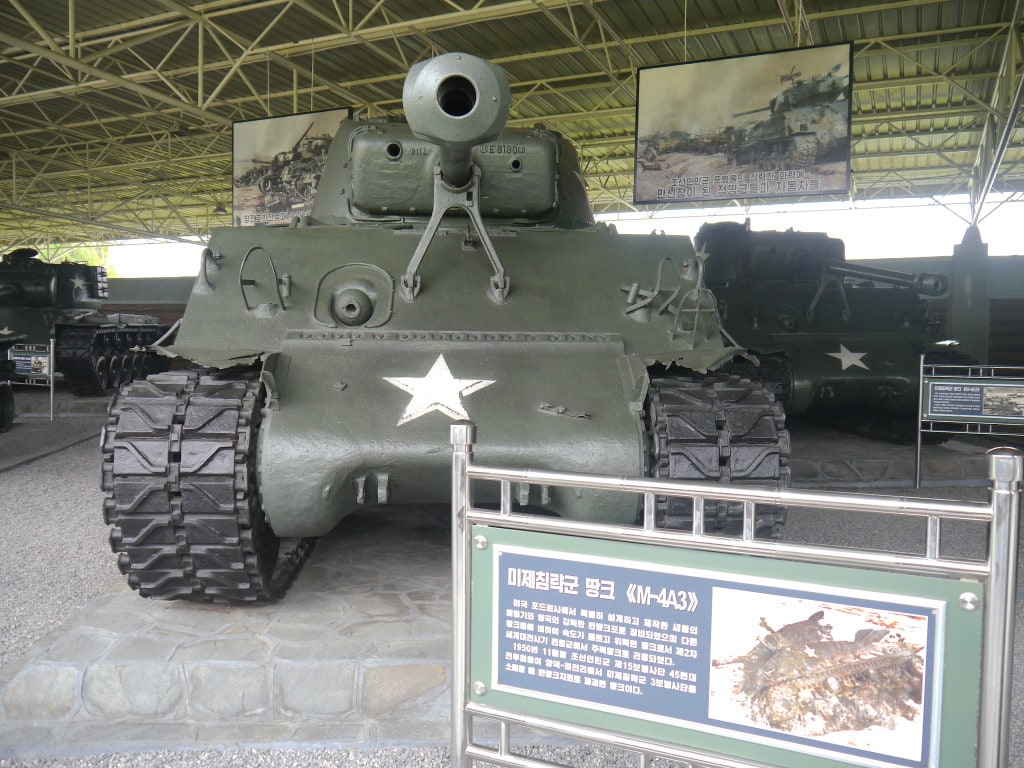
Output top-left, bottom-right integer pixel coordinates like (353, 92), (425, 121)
(401, 53), (510, 188)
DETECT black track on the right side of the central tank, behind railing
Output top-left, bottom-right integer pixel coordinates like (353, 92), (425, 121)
(647, 374), (790, 538)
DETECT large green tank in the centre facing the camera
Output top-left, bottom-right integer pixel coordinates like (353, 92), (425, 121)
(103, 53), (788, 601)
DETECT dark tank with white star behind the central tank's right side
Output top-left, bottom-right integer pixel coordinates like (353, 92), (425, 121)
(694, 219), (954, 442)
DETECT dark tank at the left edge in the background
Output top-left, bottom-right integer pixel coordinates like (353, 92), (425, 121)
(0, 248), (167, 395)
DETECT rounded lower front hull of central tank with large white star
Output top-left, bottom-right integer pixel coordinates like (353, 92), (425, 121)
(258, 331), (646, 537)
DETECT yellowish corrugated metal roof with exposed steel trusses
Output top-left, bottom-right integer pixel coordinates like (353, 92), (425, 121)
(0, 0), (1024, 250)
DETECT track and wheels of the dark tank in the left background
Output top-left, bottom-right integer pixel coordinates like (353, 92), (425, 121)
(55, 325), (167, 397)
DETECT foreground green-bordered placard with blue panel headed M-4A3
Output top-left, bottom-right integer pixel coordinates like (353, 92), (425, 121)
(472, 526), (981, 768)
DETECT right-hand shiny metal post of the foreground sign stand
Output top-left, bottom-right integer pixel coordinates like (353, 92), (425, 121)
(978, 447), (1024, 768)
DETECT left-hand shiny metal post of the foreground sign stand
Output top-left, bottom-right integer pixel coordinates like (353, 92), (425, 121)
(451, 421), (476, 768)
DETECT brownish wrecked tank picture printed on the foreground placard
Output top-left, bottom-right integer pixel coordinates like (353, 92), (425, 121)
(708, 589), (934, 765)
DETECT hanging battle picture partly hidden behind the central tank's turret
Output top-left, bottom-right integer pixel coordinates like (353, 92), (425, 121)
(231, 109), (349, 226)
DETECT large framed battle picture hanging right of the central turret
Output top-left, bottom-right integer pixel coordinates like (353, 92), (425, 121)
(633, 44), (853, 204)
